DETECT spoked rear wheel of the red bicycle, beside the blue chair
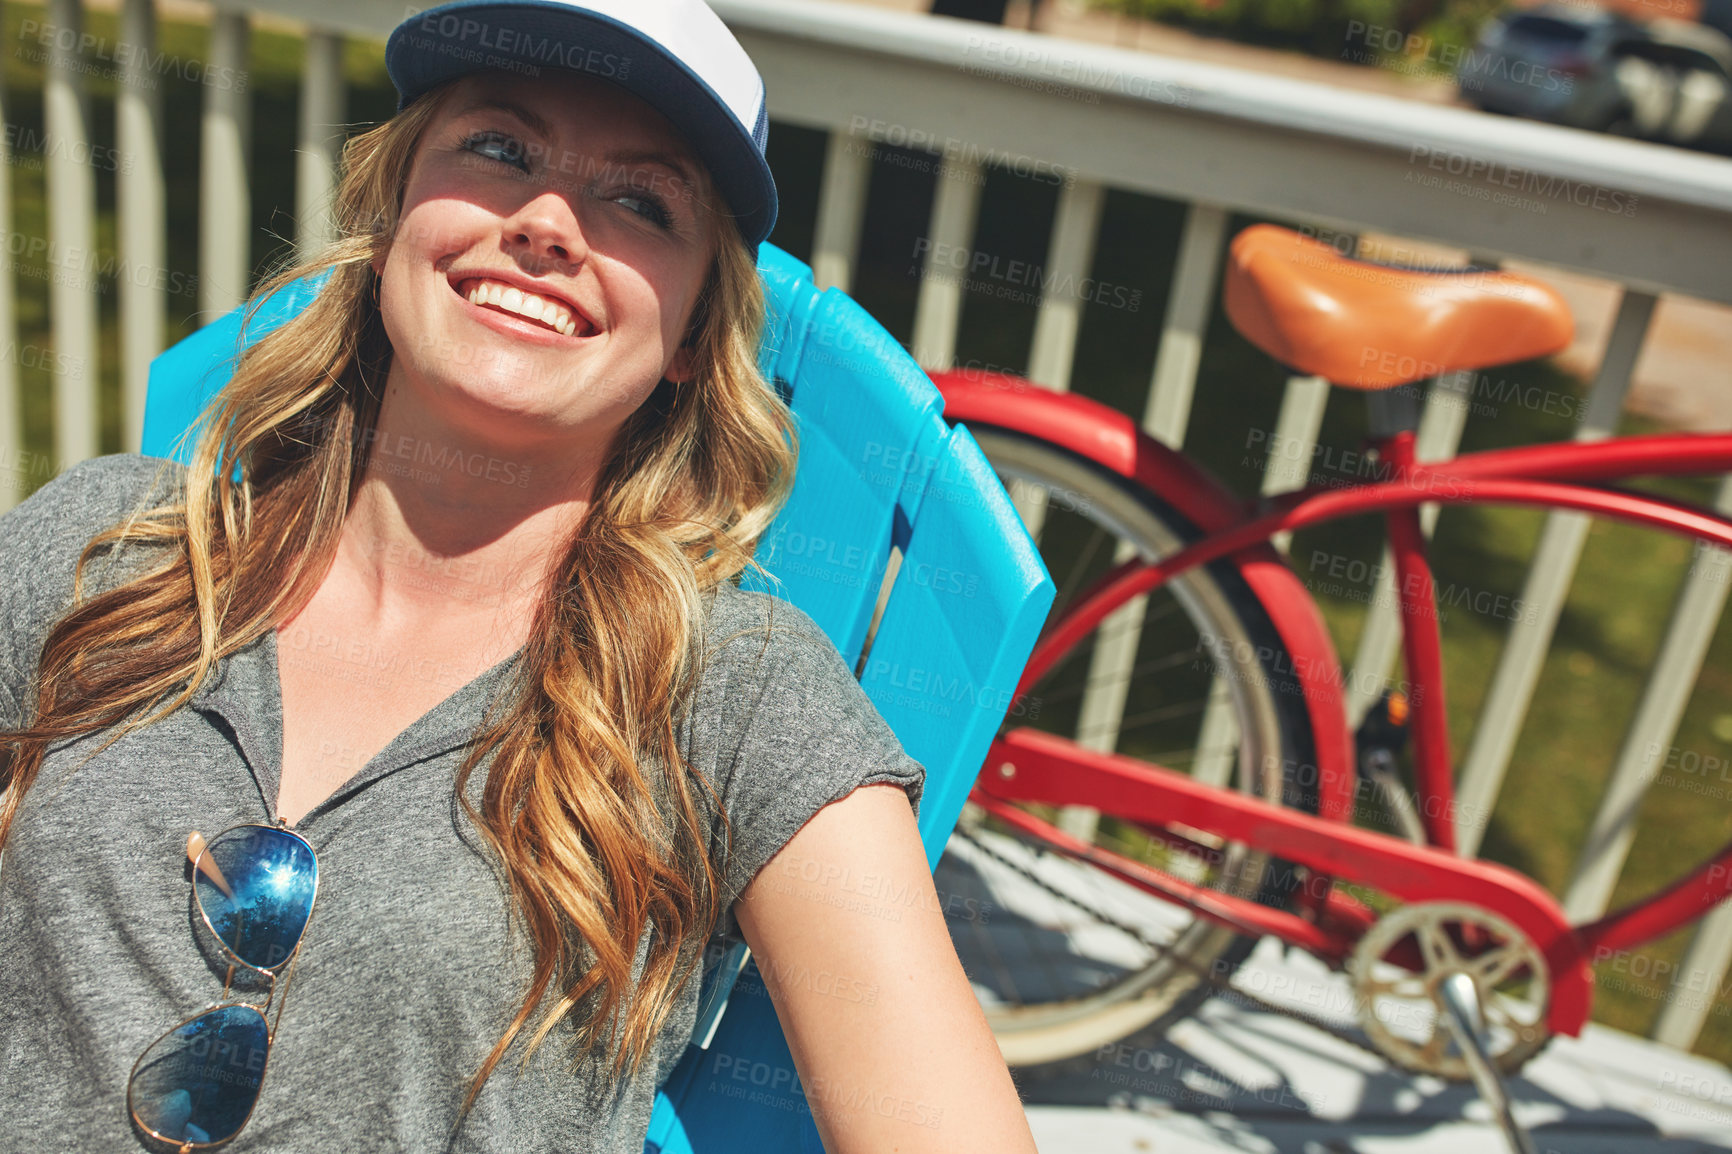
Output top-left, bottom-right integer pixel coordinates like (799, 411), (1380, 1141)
(937, 423), (1316, 1066)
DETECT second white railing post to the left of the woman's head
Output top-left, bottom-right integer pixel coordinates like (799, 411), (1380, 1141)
(199, 10), (253, 324)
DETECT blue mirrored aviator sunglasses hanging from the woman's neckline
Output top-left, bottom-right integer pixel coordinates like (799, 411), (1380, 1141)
(126, 825), (319, 1154)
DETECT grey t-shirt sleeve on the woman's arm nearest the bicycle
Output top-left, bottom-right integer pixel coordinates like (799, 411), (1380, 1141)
(695, 587), (927, 937)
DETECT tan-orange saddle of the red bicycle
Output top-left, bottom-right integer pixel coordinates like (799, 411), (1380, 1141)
(1225, 224), (1574, 388)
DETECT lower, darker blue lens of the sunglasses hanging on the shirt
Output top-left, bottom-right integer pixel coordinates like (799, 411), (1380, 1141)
(126, 1005), (270, 1142)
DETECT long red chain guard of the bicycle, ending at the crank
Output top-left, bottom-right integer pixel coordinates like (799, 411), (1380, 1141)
(975, 728), (1593, 1036)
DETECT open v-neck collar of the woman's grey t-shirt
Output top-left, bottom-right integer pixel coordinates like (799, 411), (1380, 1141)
(192, 629), (523, 832)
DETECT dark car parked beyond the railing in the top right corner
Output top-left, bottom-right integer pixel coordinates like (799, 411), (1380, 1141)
(1457, 5), (1732, 151)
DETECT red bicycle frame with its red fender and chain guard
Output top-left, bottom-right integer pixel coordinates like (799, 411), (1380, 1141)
(934, 373), (1732, 1034)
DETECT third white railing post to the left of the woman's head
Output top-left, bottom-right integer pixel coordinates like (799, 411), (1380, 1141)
(114, 0), (168, 452)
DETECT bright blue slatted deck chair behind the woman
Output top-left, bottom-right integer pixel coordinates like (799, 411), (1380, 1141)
(142, 244), (1055, 1154)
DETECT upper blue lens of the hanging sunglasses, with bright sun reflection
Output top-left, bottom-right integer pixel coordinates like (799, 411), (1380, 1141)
(192, 827), (319, 970)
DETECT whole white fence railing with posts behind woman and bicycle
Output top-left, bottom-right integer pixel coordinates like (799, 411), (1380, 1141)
(10, 0), (1732, 1048)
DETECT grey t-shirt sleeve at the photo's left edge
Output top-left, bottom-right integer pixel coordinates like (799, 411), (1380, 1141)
(0, 452), (185, 729)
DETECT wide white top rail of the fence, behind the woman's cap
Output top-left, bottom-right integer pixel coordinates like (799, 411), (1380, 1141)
(237, 0), (1732, 301)
